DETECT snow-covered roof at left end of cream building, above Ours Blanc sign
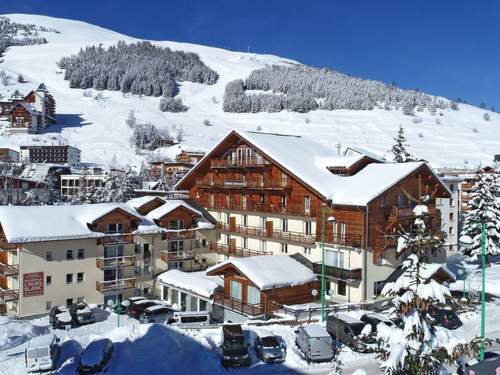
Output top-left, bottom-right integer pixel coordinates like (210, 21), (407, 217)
(0, 203), (142, 243)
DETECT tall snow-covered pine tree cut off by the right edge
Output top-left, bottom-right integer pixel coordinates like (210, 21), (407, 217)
(460, 170), (500, 257)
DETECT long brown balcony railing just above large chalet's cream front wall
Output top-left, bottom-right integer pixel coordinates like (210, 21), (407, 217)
(206, 202), (316, 217)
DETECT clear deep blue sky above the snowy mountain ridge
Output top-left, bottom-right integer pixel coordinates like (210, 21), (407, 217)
(0, 0), (500, 110)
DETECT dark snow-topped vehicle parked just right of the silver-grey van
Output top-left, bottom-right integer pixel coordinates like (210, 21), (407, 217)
(326, 313), (376, 353)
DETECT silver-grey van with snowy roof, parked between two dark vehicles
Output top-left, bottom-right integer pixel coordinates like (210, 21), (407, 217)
(295, 324), (334, 363)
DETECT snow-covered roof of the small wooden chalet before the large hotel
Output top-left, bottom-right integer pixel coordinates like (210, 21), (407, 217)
(207, 255), (318, 290)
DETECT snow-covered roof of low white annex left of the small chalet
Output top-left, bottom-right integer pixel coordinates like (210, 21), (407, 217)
(157, 270), (224, 298)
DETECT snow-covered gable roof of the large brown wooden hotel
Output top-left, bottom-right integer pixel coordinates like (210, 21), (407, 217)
(175, 130), (446, 206)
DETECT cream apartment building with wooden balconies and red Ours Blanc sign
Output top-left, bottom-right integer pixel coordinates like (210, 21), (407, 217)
(0, 196), (214, 317)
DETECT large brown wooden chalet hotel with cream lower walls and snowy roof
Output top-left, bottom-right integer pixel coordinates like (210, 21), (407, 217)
(176, 131), (450, 302)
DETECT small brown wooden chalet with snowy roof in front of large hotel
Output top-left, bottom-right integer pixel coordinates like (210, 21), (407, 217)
(207, 255), (320, 321)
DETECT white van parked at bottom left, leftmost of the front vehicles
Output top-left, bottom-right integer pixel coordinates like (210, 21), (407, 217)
(24, 334), (60, 372)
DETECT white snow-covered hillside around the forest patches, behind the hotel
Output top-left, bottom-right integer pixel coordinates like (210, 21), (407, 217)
(0, 14), (500, 167)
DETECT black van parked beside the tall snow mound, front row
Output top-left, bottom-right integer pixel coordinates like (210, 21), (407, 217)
(220, 324), (251, 367)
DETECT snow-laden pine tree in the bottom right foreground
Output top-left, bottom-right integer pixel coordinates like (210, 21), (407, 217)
(377, 195), (477, 375)
